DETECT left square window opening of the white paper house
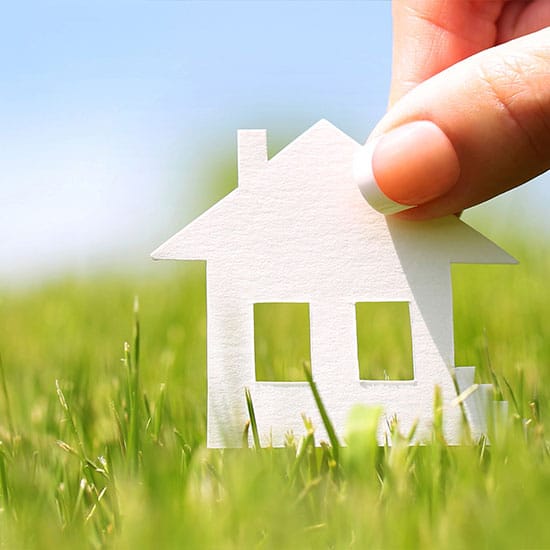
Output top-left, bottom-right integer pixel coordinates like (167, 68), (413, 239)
(254, 303), (311, 382)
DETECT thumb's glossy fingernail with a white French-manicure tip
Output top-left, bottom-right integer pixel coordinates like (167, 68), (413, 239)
(354, 120), (460, 214)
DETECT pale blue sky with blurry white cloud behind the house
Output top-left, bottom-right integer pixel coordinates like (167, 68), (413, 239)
(0, 0), (548, 288)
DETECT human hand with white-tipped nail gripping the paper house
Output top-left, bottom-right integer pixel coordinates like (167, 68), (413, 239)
(358, 0), (550, 220)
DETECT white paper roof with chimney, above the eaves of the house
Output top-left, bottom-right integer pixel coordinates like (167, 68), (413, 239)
(152, 120), (516, 267)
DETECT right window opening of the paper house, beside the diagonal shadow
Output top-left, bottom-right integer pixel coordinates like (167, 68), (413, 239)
(355, 302), (414, 380)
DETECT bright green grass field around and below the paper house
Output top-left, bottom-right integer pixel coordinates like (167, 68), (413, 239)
(0, 235), (550, 549)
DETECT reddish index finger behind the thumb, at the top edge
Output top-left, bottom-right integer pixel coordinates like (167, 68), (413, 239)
(390, 0), (502, 105)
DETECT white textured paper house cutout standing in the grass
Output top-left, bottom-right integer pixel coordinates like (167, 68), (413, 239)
(152, 120), (515, 447)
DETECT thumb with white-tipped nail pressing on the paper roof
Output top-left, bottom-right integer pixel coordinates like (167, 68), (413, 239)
(356, 27), (550, 219)
